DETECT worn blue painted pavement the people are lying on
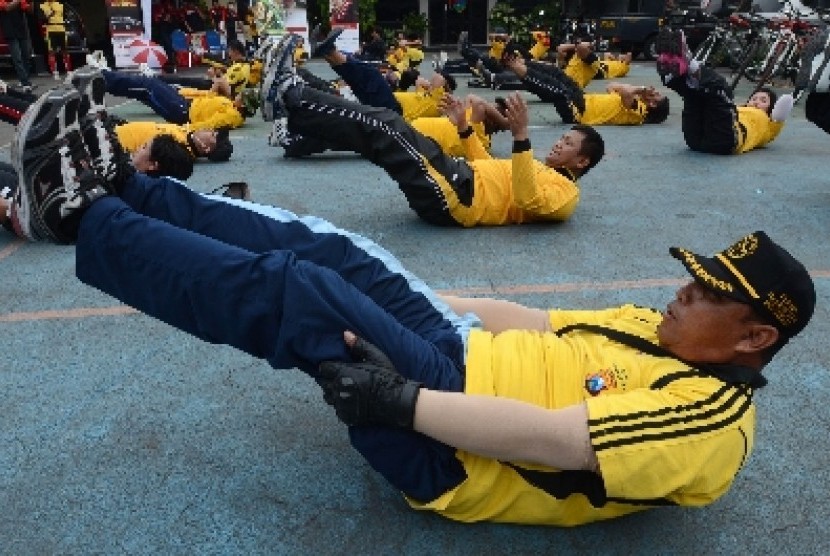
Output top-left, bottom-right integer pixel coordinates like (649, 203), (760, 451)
(0, 58), (830, 554)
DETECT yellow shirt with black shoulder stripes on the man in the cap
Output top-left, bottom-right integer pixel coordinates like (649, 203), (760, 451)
(409, 305), (755, 526)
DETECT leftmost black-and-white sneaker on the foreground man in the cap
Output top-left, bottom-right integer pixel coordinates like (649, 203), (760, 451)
(10, 87), (107, 243)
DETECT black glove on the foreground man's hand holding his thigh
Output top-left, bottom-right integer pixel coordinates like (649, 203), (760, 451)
(320, 338), (421, 429)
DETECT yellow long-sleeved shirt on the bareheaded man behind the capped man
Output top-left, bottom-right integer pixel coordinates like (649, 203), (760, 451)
(436, 133), (579, 227)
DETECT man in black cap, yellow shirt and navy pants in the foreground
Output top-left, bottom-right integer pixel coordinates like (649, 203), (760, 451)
(6, 87), (815, 525)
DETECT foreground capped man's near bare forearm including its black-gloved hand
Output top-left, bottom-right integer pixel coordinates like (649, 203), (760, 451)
(320, 332), (599, 471)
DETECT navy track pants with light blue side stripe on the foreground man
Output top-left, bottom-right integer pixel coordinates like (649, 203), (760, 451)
(76, 174), (468, 501)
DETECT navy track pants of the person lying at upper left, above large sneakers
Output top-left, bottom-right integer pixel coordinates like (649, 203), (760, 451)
(102, 70), (190, 125)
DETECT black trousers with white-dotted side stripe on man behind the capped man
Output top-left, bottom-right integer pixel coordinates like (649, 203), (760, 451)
(284, 86), (474, 226)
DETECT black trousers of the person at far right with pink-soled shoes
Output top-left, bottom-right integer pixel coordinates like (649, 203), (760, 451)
(666, 67), (740, 154)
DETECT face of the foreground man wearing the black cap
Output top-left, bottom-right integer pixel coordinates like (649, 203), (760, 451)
(657, 281), (757, 363)
